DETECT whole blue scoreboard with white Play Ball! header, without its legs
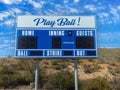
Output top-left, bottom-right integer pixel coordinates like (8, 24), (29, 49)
(15, 15), (97, 58)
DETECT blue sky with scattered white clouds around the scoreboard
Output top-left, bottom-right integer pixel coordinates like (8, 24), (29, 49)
(0, 0), (120, 57)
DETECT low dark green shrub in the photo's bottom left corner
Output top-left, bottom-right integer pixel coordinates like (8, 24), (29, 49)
(0, 74), (30, 88)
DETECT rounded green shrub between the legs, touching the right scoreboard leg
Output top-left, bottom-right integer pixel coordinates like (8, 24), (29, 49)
(45, 71), (74, 90)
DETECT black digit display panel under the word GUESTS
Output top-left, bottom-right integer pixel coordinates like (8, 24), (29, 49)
(76, 36), (95, 49)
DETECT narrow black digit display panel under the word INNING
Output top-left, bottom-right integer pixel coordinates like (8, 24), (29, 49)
(52, 37), (61, 49)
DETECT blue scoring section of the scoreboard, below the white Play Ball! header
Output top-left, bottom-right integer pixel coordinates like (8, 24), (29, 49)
(15, 29), (97, 58)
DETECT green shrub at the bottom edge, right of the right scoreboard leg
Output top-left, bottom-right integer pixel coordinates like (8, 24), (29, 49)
(79, 77), (112, 90)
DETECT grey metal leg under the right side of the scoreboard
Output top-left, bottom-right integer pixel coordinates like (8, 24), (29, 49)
(74, 59), (78, 90)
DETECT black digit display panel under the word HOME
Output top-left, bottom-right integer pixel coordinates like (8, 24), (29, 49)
(18, 36), (37, 49)
